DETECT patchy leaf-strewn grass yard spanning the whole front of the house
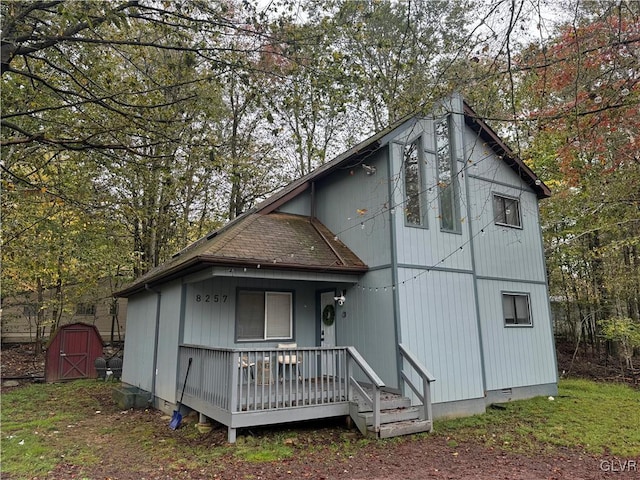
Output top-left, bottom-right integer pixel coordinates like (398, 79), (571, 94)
(0, 380), (640, 479)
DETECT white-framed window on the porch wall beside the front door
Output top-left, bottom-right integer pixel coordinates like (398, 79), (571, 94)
(236, 290), (293, 341)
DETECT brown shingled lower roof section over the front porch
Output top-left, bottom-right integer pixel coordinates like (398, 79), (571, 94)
(117, 212), (367, 297)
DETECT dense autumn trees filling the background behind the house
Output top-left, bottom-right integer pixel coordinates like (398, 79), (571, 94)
(0, 0), (640, 364)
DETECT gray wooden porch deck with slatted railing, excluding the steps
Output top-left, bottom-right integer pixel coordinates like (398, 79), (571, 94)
(176, 345), (372, 442)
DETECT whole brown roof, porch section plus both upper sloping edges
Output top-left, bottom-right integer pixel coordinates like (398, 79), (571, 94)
(116, 97), (551, 297)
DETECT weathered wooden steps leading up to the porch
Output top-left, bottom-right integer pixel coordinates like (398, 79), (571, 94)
(350, 392), (432, 438)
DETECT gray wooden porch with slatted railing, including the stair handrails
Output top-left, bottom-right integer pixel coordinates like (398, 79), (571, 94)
(176, 345), (433, 442)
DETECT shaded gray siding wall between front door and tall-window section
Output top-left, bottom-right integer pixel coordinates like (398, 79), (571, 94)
(316, 147), (398, 388)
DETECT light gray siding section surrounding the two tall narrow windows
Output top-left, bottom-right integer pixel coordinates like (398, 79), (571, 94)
(382, 99), (484, 403)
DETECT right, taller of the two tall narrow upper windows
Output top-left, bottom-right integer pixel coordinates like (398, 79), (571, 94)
(436, 117), (460, 232)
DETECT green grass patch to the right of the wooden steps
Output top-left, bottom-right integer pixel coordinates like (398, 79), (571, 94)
(435, 380), (640, 458)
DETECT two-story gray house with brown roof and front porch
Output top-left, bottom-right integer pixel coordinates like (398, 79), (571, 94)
(119, 96), (557, 442)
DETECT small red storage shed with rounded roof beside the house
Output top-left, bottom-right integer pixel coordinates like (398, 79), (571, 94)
(44, 323), (104, 382)
